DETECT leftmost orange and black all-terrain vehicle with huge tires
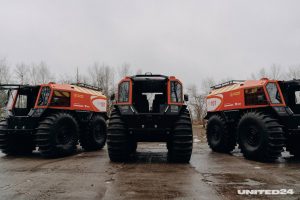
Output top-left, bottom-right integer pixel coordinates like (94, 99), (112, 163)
(0, 83), (108, 157)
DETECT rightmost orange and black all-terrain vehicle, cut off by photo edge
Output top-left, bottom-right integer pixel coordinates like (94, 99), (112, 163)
(206, 78), (300, 161)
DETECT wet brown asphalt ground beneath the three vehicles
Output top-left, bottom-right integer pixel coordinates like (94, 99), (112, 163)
(0, 127), (300, 200)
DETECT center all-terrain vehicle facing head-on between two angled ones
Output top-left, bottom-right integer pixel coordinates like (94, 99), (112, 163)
(107, 73), (193, 163)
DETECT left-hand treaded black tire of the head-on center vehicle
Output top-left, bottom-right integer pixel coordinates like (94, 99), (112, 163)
(107, 108), (133, 162)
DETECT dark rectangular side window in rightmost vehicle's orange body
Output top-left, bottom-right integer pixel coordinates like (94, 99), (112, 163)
(245, 87), (267, 106)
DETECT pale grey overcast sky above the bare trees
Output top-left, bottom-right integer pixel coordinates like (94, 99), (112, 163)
(0, 0), (300, 84)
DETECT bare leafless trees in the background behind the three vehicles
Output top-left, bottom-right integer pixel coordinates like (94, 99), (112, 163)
(0, 58), (300, 124)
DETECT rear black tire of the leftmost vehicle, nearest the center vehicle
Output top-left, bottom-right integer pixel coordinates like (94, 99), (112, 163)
(80, 115), (107, 151)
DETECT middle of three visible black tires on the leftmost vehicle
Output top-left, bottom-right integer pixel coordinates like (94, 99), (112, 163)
(36, 112), (79, 158)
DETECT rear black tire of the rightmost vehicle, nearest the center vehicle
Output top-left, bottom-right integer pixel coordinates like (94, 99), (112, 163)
(206, 115), (236, 153)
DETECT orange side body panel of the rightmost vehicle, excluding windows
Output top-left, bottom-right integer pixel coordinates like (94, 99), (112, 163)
(207, 79), (285, 112)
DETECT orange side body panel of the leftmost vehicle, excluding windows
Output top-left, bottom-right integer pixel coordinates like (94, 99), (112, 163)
(35, 83), (107, 112)
